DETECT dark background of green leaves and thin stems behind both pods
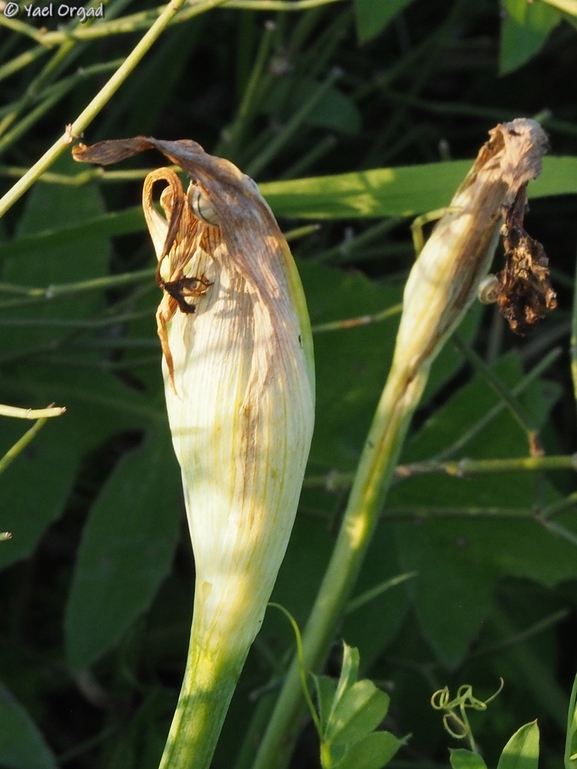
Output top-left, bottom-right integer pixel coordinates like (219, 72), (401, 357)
(0, 0), (577, 769)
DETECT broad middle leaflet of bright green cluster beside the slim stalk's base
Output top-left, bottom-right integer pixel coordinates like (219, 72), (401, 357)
(326, 679), (390, 745)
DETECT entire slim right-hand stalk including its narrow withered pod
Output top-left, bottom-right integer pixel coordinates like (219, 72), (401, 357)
(253, 119), (546, 769)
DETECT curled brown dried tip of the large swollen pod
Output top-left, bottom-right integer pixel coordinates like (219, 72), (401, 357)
(72, 136), (308, 392)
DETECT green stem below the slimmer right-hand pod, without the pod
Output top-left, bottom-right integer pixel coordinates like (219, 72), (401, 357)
(253, 366), (428, 769)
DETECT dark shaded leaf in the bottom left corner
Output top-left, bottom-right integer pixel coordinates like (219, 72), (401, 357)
(0, 684), (57, 769)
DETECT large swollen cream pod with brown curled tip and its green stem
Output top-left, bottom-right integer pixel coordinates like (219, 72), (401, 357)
(75, 138), (314, 769)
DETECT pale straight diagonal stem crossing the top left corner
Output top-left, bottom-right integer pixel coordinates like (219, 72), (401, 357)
(0, 0), (191, 217)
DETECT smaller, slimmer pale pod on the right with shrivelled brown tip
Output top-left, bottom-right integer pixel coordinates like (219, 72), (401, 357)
(394, 118), (554, 376)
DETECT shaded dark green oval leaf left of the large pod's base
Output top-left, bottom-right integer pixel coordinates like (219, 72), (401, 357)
(65, 433), (182, 670)
